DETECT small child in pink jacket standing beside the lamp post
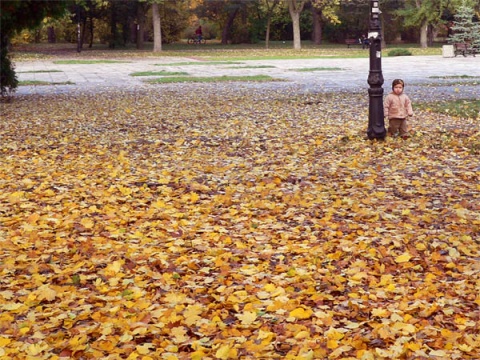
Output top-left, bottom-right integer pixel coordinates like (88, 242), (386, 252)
(383, 79), (413, 139)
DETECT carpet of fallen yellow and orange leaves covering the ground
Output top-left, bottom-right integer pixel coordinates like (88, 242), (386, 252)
(0, 85), (480, 360)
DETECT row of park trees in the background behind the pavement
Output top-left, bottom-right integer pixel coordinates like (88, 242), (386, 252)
(0, 0), (480, 94)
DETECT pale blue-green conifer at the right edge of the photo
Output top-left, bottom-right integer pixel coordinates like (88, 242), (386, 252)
(448, 2), (480, 49)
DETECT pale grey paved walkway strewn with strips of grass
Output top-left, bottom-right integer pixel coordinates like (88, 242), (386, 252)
(15, 56), (480, 98)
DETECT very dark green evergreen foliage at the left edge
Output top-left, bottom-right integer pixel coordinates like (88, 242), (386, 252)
(0, 0), (66, 96)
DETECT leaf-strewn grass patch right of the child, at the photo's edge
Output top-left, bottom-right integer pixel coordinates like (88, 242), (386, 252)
(417, 99), (480, 119)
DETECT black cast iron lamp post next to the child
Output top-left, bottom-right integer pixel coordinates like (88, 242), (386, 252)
(367, 0), (387, 140)
